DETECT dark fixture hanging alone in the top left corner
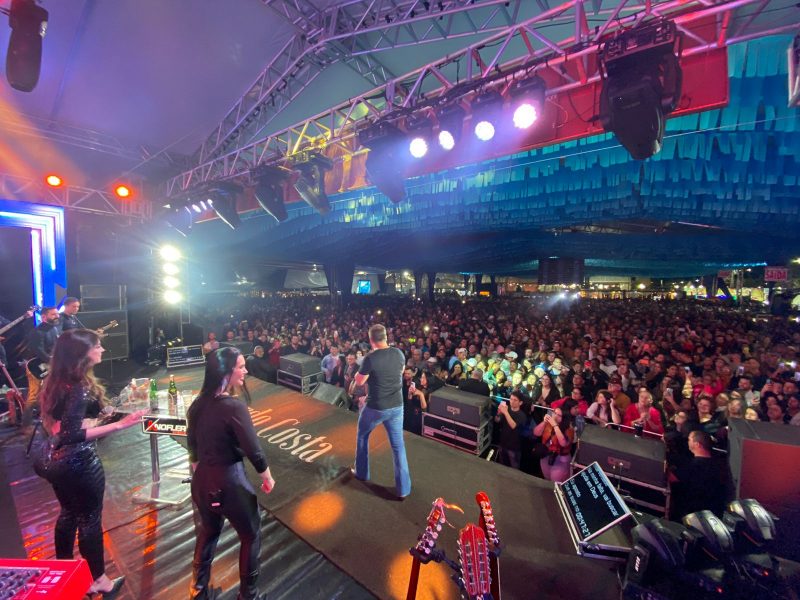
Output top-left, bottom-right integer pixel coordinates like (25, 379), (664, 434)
(6, 0), (48, 92)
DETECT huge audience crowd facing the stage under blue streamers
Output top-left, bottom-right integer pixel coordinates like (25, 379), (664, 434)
(195, 297), (800, 516)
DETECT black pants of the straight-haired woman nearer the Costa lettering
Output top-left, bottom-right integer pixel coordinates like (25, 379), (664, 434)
(190, 462), (261, 599)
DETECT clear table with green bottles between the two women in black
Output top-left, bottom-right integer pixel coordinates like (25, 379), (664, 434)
(114, 375), (195, 506)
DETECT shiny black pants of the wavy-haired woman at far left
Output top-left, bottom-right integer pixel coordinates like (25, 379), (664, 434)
(47, 444), (106, 579)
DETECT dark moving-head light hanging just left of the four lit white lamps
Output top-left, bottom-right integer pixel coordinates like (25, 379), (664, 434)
(358, 122), (407, 204)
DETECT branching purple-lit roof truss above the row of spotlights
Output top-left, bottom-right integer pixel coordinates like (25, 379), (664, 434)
(199, 0), (528, 163)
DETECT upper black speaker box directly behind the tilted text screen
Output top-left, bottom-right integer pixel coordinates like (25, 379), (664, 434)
(575, 425), (667, 489)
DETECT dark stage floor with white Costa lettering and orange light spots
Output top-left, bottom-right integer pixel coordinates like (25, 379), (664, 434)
(3, 370), (619, 600)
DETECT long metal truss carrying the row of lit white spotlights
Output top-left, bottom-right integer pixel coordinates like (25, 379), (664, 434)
(165, 0), (797, 196)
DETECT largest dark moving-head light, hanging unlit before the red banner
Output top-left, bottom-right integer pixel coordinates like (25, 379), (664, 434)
(599, 21), (683, 160)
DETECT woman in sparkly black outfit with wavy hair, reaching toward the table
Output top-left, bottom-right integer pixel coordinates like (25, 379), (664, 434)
(41, 329), (145, 598)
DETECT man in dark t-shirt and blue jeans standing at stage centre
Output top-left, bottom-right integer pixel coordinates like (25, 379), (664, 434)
(354, 325), (411, 499)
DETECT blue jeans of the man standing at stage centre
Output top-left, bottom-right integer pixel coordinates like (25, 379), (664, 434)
(356, 406), (411, 497)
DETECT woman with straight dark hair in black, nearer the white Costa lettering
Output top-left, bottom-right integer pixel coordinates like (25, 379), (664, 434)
(187, 348), (275, 600)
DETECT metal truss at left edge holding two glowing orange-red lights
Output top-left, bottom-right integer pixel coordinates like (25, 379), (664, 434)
(0, 173), (152, 222)
